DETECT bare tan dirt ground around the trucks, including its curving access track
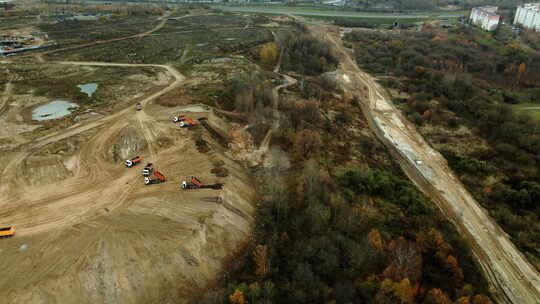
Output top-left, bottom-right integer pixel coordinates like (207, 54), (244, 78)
(0, 13), (255, 303)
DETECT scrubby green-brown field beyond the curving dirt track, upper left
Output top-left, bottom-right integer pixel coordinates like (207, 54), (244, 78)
(50, 14), (273, 71)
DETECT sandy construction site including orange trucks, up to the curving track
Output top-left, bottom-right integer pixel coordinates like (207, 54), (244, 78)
(0, 7), (268, 303)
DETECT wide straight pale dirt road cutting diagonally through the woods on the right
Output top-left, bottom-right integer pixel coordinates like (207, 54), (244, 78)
(318, 27), (540, 304)
